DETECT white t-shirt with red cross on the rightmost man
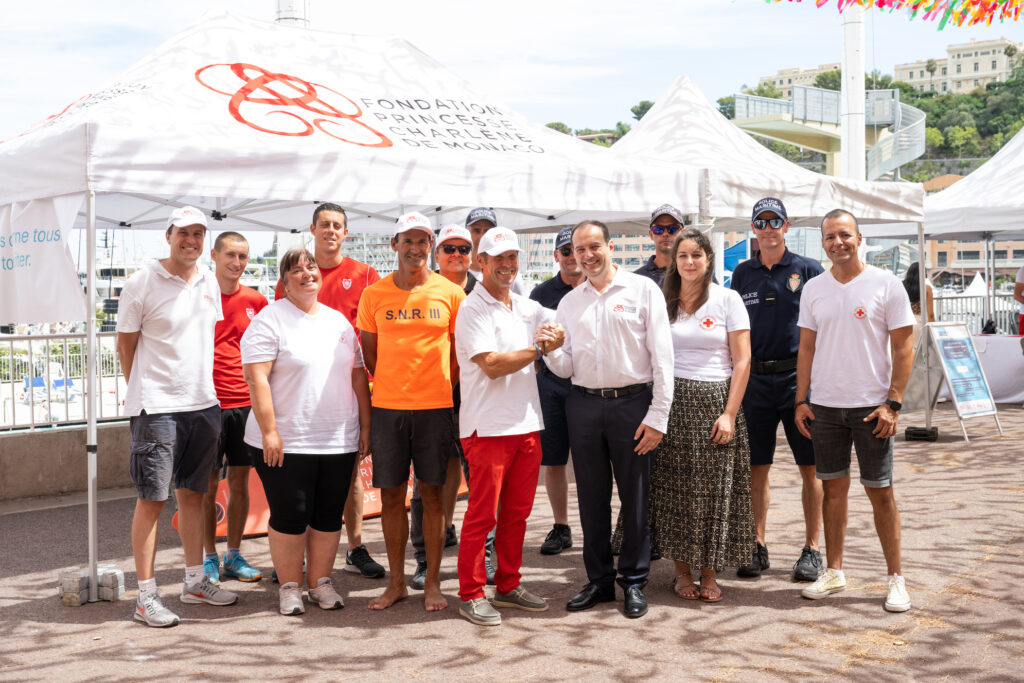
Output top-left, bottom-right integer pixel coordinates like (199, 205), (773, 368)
(797, 265), (914, 408)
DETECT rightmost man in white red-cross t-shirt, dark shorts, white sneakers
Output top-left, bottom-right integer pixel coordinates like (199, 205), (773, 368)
(795, 209), (914, 612)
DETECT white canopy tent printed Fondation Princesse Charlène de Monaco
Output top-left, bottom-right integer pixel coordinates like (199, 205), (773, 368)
(0, 13), (698, 599)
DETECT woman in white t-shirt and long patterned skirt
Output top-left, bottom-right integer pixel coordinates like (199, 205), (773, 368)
(650, 228), (755, 602)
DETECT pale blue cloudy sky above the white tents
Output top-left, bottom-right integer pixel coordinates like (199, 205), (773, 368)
(0, 0), (1024, 139)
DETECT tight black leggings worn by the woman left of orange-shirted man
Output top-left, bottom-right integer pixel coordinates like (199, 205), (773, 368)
(249, 446), (355, 535)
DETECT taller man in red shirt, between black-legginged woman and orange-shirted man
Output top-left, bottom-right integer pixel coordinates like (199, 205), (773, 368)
(274, 202), (384, 579)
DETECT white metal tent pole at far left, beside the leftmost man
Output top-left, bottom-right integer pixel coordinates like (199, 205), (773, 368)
(85, 189), (99, 602)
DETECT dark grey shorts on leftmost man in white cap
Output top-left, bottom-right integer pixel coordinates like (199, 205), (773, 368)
(129, 405), (220, 501)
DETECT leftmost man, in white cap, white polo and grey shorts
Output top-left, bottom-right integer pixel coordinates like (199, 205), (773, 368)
(117, 207), (238, 627)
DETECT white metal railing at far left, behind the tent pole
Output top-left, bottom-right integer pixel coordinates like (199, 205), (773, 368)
(0, 333), (125, 432)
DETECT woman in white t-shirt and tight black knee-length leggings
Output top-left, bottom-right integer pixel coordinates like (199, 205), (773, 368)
(242, 249), (370, 614)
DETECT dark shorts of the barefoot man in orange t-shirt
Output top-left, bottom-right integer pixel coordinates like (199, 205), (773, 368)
(370, 407), (459, 488)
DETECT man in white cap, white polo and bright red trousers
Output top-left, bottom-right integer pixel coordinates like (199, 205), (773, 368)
(455, 227), (564, 626)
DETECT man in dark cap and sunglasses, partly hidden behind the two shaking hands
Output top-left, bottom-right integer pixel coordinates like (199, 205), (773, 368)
(529, 227), (584, 555)
